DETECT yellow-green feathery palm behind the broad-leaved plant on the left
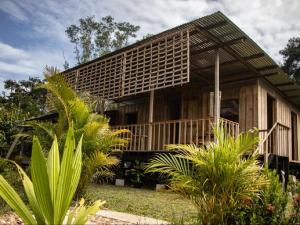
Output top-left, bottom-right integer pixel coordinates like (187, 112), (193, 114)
(23, 67), (127, 194)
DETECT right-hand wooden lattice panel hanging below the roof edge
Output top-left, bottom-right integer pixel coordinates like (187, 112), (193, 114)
(123, 31), (189, 96)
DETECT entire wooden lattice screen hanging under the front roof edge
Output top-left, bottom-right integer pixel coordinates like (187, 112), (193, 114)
(64, 29), (189, 99)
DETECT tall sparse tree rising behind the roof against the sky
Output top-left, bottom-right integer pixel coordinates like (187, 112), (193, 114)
(66, 16), (140, 64)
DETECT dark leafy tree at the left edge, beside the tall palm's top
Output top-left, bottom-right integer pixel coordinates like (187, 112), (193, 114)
(0, 77), (46, 117)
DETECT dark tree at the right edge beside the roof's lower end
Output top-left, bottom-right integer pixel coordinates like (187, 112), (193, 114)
(279, 37), (300, 82)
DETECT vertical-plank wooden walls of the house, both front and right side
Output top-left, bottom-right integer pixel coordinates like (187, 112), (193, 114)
(114, 80), (300, 161)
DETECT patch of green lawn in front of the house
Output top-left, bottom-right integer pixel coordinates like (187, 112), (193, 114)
(86, 185), (197, 223)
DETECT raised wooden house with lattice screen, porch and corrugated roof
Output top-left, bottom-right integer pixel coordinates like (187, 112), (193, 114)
(64, 12), (300, 174)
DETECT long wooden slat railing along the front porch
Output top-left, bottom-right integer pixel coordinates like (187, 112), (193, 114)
(112, 118), (239, 151)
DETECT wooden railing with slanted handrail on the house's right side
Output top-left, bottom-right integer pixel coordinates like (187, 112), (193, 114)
(256, 122), (290, 163)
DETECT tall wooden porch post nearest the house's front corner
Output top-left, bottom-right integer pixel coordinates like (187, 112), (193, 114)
(214, 49), (220, 124)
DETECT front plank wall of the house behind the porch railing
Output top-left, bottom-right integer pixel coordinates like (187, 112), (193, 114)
(118, 85), (258, 131)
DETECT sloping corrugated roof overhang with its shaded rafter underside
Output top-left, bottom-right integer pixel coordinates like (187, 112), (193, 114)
(64, 12), (300, 107)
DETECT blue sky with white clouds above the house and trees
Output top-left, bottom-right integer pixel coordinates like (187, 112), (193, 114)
(0, 0), (300, 90)
